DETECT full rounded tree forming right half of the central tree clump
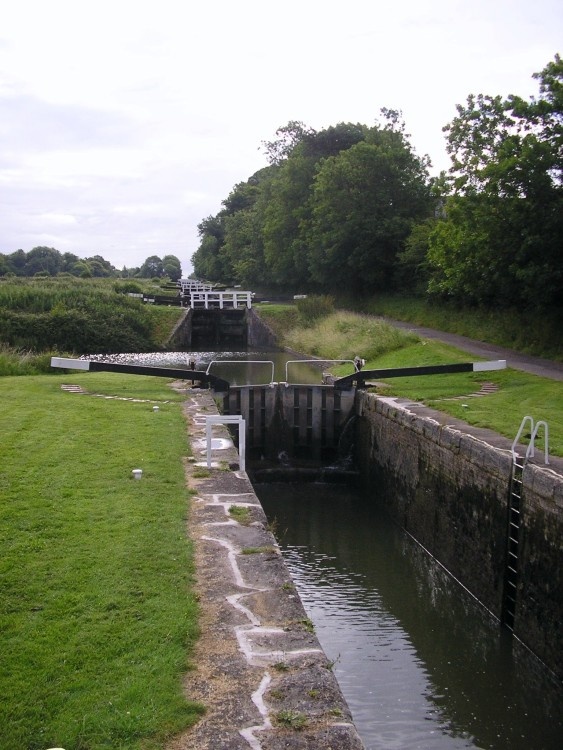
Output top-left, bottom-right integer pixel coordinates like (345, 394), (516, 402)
(309, 128), (430, 292)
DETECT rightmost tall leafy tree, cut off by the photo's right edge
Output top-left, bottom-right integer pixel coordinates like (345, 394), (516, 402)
(428, 56), (563, 306)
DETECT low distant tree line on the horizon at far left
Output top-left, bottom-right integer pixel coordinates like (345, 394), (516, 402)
(0, 246), (182, 281)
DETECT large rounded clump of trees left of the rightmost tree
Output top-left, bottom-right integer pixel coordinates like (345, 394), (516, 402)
(192, 111), (430, 291)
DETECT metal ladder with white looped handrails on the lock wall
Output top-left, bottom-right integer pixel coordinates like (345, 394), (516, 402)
(501, 416), (549, 631)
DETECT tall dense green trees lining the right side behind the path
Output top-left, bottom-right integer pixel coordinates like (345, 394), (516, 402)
(192, 55), (563, 309)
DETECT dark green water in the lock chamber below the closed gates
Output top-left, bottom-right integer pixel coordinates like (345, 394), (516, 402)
(255, 484), (563, 750)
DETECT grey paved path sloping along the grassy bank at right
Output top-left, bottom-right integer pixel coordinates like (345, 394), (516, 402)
(384, 318), (563, 380)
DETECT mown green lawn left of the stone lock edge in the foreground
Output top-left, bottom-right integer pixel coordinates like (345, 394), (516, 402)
(0, 372), (202, 750)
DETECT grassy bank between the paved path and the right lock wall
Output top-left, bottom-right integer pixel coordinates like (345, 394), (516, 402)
(259, 305), (563, 456)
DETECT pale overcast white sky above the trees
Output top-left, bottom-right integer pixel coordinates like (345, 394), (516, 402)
(0, 0), (563, 275)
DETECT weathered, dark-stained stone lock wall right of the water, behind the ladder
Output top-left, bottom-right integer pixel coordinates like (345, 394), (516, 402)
(356, 392), (563, 677)
